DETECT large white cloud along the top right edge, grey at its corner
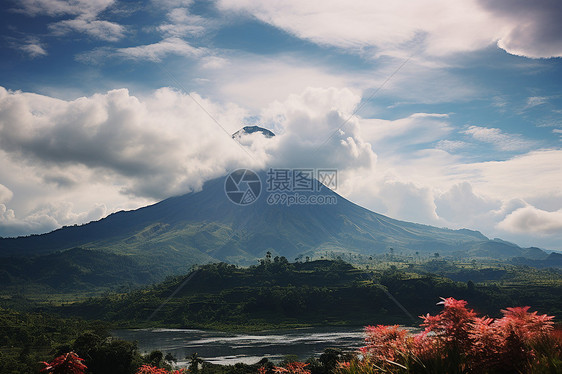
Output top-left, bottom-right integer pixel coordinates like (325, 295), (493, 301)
(218, 0), (562, 58)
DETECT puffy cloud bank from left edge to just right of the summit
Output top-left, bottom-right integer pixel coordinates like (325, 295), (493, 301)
(0, 88), (376, 235)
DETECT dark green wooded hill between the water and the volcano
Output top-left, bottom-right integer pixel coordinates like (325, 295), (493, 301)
(56, 257), (562, 329)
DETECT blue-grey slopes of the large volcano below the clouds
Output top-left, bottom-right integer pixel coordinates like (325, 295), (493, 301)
(0, 173), (546, 272)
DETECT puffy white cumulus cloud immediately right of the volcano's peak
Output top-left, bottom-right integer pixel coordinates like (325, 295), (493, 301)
(261, 88), (376, 169)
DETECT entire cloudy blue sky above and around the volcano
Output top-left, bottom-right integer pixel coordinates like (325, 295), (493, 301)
(0, 0), (562, 250)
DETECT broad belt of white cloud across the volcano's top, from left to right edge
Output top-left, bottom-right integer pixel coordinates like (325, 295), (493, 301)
(0, 87), (562, 248)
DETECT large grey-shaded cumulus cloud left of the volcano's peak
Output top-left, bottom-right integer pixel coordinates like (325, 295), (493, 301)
(0, 89), (252, 199)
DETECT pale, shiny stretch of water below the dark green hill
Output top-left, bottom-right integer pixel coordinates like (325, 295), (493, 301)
(113, 327), (364, 366)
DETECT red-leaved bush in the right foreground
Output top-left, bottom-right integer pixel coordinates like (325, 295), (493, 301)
(336, 298), (562, 374)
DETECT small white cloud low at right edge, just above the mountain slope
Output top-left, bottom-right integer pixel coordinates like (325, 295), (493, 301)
(498, 205), (562, 235)
